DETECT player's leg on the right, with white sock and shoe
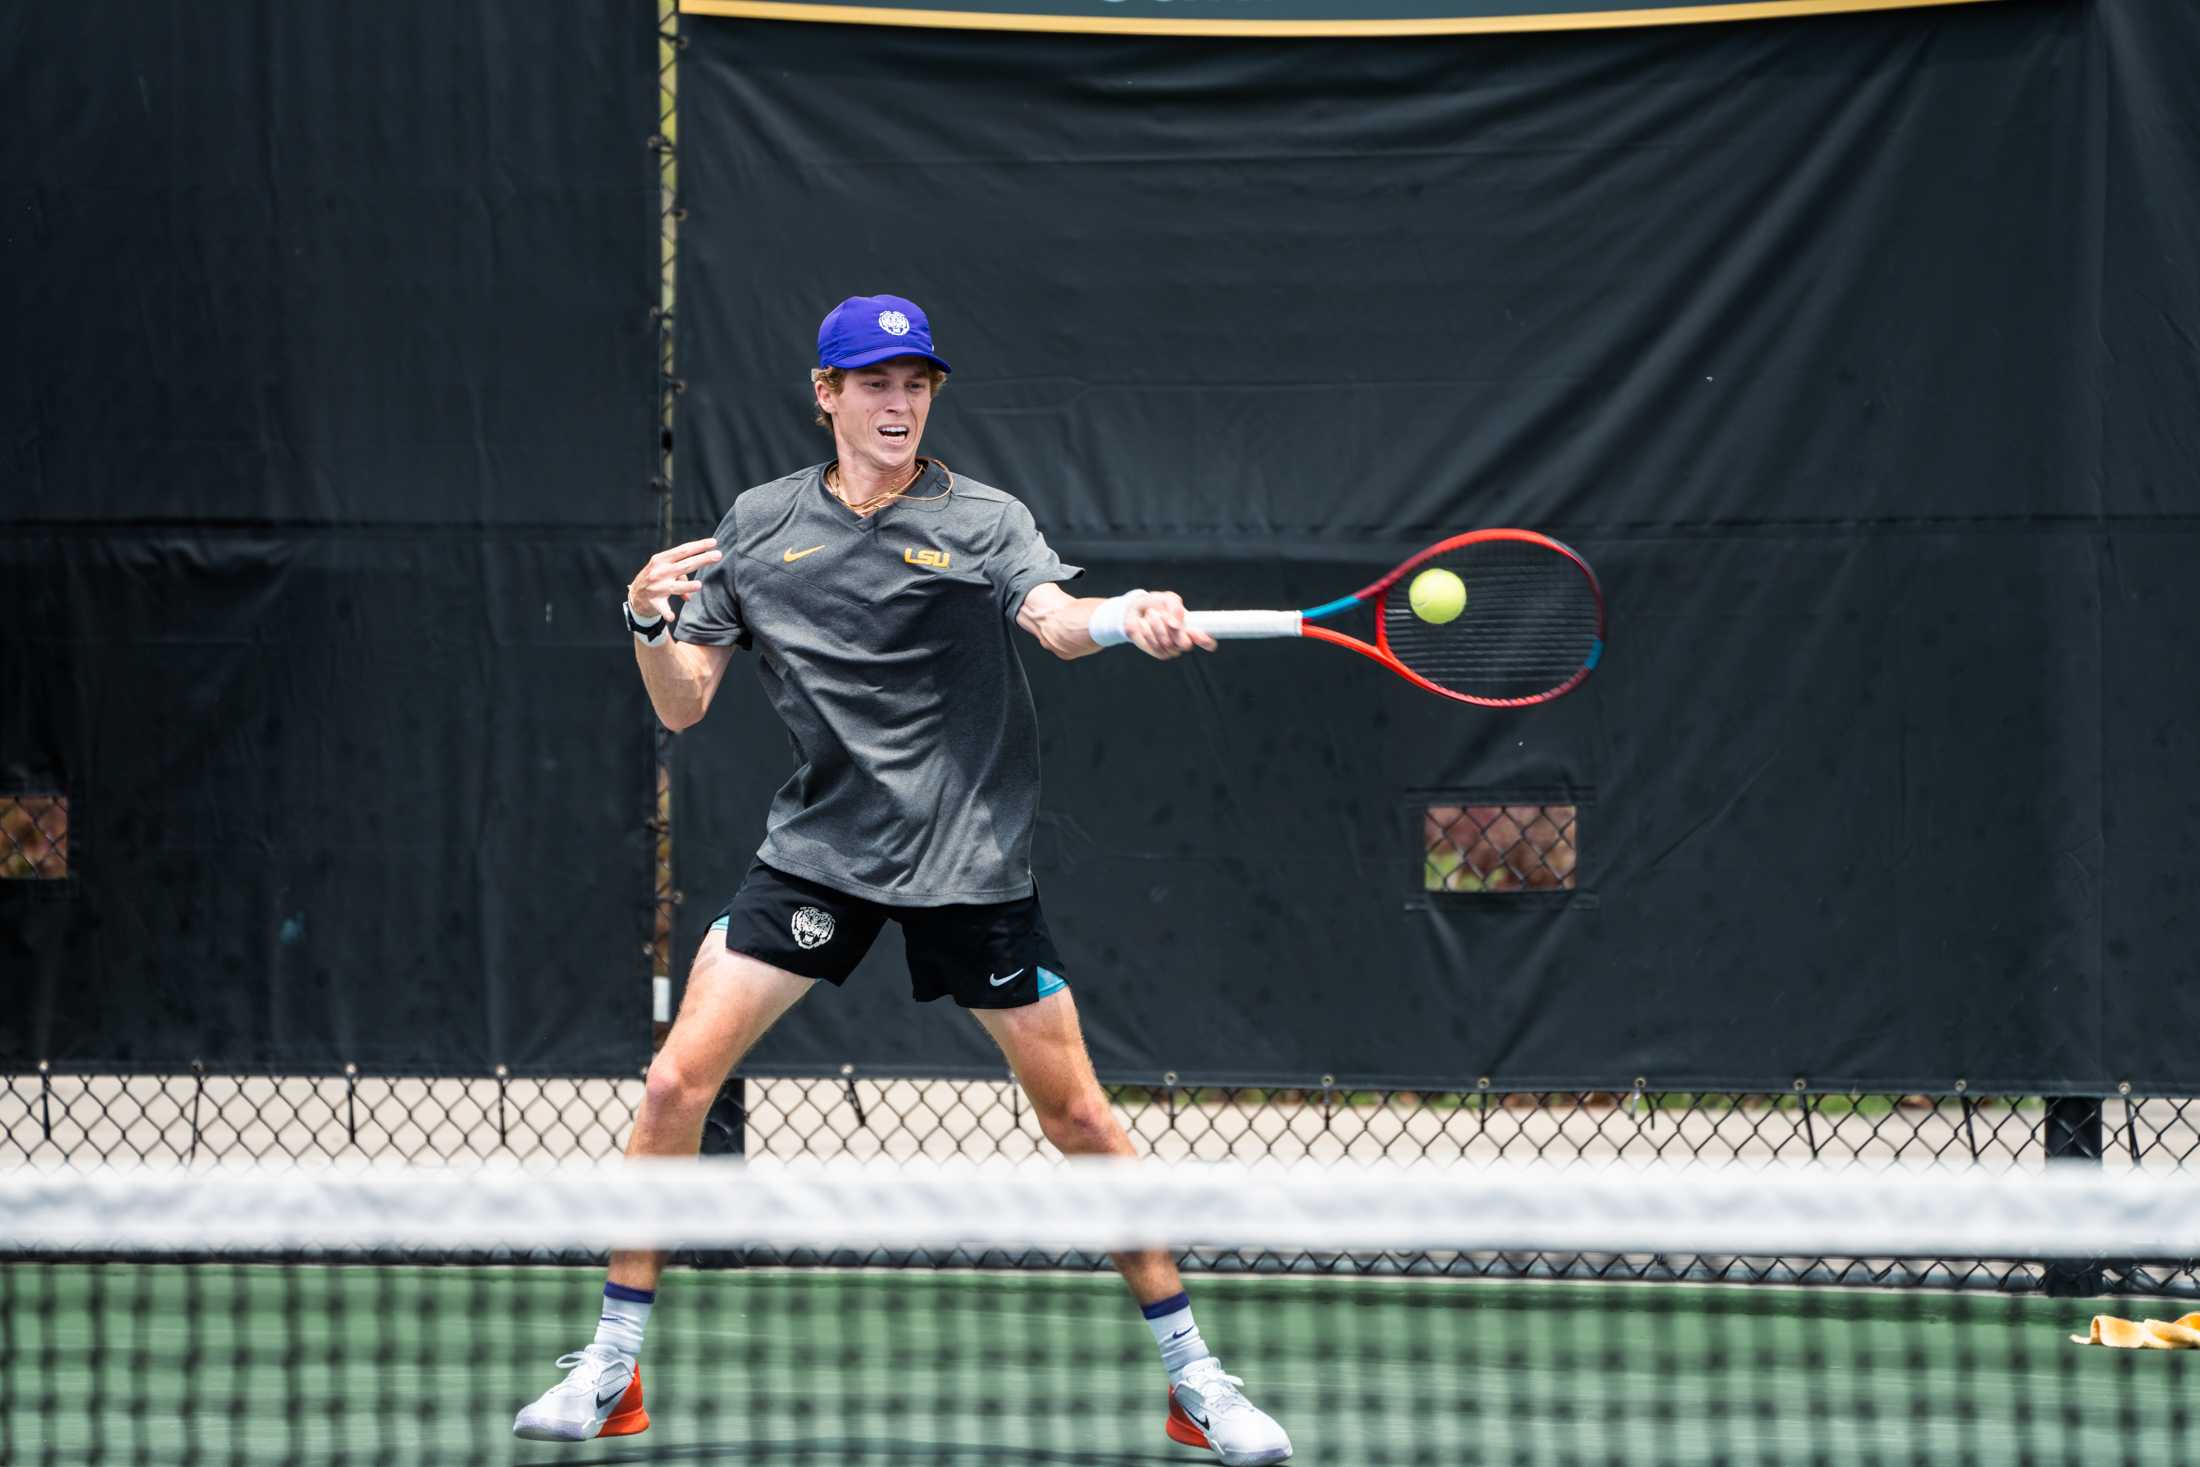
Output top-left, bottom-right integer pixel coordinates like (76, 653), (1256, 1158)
(972, 988), (1291, 1467)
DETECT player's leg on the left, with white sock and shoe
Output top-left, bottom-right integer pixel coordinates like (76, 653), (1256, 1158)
(513, 933), (812, 1441)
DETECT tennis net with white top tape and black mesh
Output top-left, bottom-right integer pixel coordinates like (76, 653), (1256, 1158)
(0, 1163), (2200, 1467)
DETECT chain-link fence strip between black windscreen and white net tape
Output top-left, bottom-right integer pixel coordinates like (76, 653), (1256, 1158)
(17, 1071), (2200, 1170)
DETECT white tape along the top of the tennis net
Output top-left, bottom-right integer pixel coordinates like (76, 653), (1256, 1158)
(0, 1161), (2200, 1260)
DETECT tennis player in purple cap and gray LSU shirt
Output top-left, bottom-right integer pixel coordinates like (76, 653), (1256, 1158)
(513, 295), (1291, 1467)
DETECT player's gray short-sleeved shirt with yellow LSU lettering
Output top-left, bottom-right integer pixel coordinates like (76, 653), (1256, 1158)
(673, 464), (1082, 906)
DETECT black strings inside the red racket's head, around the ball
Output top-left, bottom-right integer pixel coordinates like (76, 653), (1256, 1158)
(1382, 541), (1604, 699)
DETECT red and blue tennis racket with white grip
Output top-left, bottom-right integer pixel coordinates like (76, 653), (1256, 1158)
(1184, 530), (1604, 708)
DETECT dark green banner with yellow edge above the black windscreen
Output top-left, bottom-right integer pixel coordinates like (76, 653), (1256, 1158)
(680, 0), (2015, 35)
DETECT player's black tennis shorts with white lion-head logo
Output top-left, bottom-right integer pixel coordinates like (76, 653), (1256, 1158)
(711, 860), (1069, 1010)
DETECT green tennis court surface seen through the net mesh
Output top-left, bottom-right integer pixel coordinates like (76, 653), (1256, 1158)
(0, 1262), (2200, 1467)
